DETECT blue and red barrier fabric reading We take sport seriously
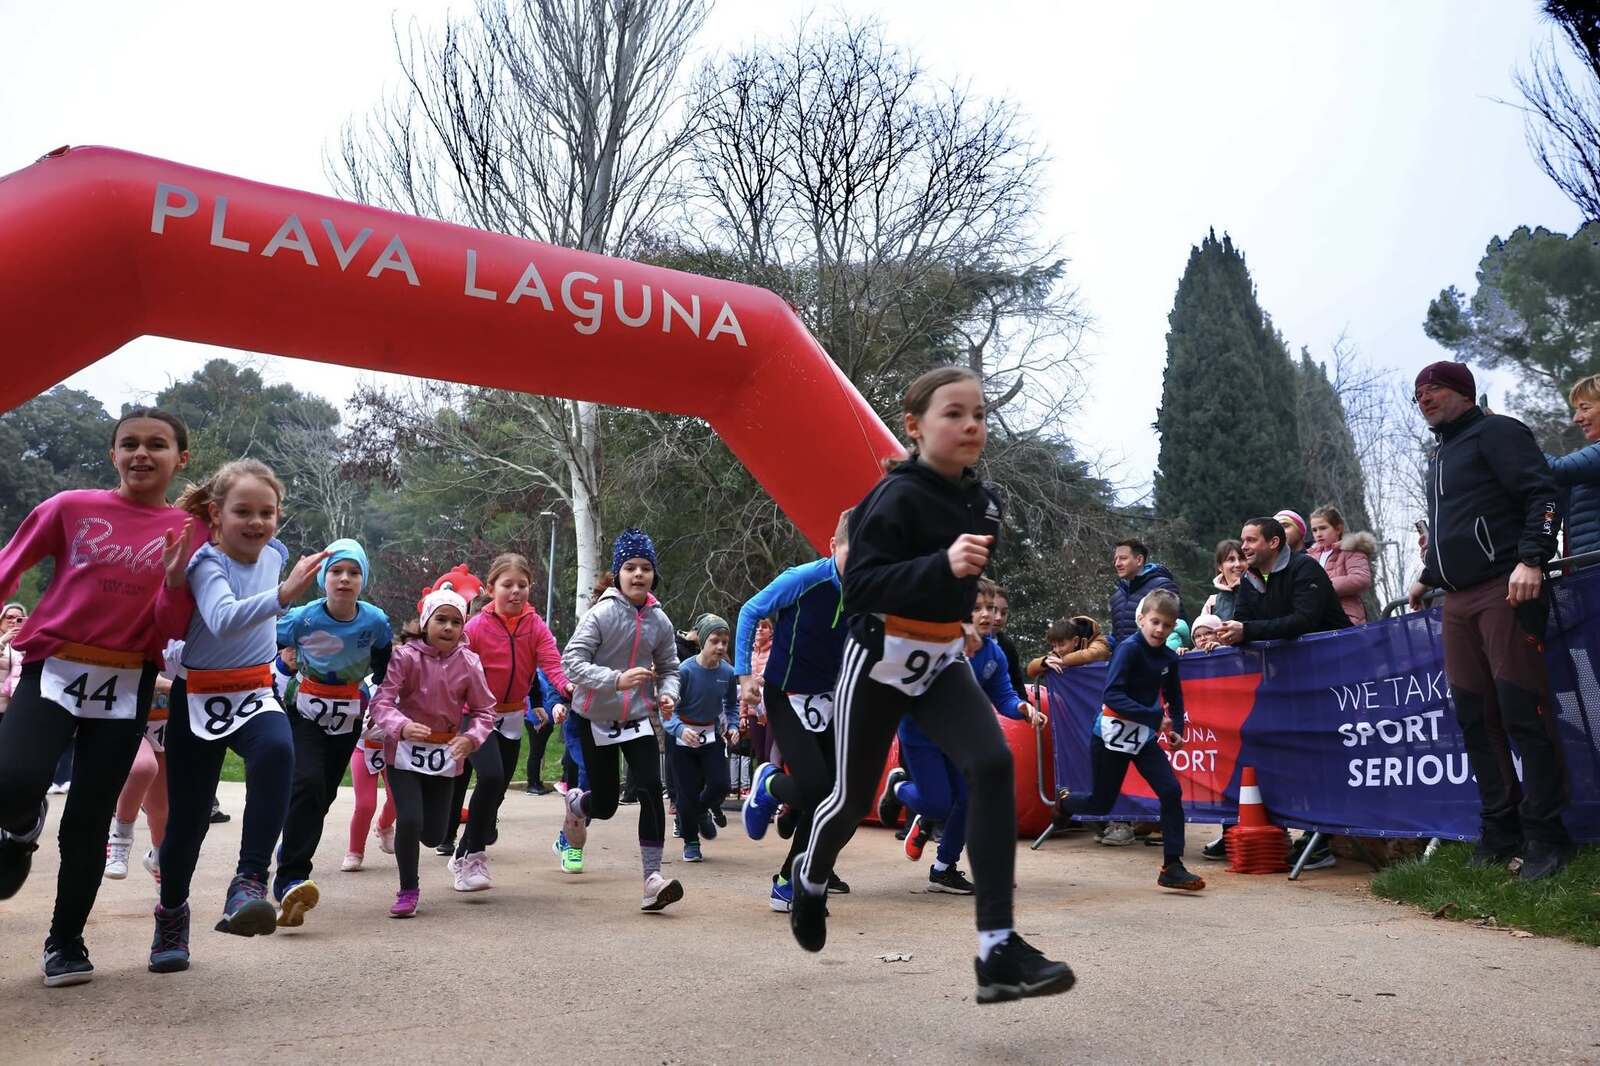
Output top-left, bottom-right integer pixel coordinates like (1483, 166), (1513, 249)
(1046, 568), (1600, 842)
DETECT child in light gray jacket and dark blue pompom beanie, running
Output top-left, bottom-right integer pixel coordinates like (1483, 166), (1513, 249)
(555, 528), (683, 911)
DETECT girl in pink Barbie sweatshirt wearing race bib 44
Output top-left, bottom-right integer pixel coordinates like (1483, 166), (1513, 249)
(0, 408), (203, 988)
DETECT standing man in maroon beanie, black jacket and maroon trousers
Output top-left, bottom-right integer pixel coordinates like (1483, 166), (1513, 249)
(1410, 362), (1573, 880)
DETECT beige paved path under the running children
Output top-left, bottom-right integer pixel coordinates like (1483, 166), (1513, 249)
(0, 784), (1600, 1064)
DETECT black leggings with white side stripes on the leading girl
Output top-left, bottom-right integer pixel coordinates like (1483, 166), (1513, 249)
(797, 637), (1016, 932)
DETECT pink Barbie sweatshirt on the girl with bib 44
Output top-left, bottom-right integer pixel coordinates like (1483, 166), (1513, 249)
(0, 488), (195, 663)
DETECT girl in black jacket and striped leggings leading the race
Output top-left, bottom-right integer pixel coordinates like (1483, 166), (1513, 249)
(789, 367), (1074, 1004)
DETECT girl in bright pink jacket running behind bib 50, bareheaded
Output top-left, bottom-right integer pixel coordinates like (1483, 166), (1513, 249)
(450, 552), (573, 892)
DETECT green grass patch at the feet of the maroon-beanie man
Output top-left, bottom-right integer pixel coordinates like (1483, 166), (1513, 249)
(1373, 844), (1600, 946)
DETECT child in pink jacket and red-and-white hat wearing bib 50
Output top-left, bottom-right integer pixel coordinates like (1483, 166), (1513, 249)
(371, 587), (496, 919)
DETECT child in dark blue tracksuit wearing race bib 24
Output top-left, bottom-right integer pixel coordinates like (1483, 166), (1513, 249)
(1058, 589), (1205, 892)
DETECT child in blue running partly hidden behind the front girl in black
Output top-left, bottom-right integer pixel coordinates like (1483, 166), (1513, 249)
(878, 578), (1045, 896)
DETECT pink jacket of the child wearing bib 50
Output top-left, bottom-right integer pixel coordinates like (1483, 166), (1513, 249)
(370, 630), (496, 771)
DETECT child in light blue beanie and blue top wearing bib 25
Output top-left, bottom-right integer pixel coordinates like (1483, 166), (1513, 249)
(272, 538), (394, 927)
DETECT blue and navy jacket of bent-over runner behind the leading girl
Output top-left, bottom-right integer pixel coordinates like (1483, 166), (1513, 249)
(733, 555), (848, 696)
